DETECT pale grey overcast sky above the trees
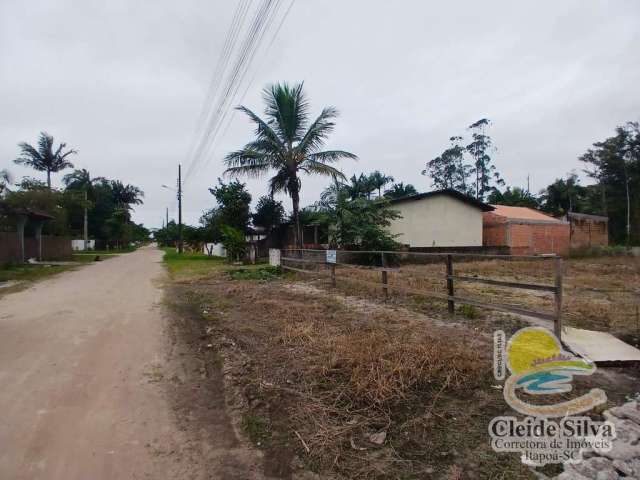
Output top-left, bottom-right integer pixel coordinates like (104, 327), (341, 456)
(0, 0), (640, 227)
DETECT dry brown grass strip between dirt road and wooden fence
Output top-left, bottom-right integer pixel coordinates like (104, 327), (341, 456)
(164, 253), (637, 479)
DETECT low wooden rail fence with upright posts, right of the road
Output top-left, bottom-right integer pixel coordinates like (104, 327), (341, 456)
(280, 249), (563, 339)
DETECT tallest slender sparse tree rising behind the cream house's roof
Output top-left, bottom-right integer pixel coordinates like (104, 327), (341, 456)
(466, 118), (504, 201)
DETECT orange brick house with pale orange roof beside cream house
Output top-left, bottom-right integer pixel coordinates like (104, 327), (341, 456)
(482, 205), (570, 255)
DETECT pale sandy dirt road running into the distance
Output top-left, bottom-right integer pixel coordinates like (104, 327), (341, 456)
(0, 248), (262, 480)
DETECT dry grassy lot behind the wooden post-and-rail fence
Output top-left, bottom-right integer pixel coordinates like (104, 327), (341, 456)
(288, 256), (640, 345)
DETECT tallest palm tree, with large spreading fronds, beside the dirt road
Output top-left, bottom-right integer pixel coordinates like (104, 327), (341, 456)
(225, 83), (357, 245)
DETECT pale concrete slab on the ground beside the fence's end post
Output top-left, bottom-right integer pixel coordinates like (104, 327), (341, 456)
(562, 327), (640, 363)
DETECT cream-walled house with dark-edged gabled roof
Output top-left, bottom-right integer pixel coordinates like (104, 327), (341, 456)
(388, 190), (493, 248)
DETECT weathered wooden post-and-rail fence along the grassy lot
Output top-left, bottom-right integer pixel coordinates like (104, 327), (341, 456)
(280, 250), (563, 339)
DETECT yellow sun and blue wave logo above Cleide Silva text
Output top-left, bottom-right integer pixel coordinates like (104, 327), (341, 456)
(504, 327), (607, 418)
